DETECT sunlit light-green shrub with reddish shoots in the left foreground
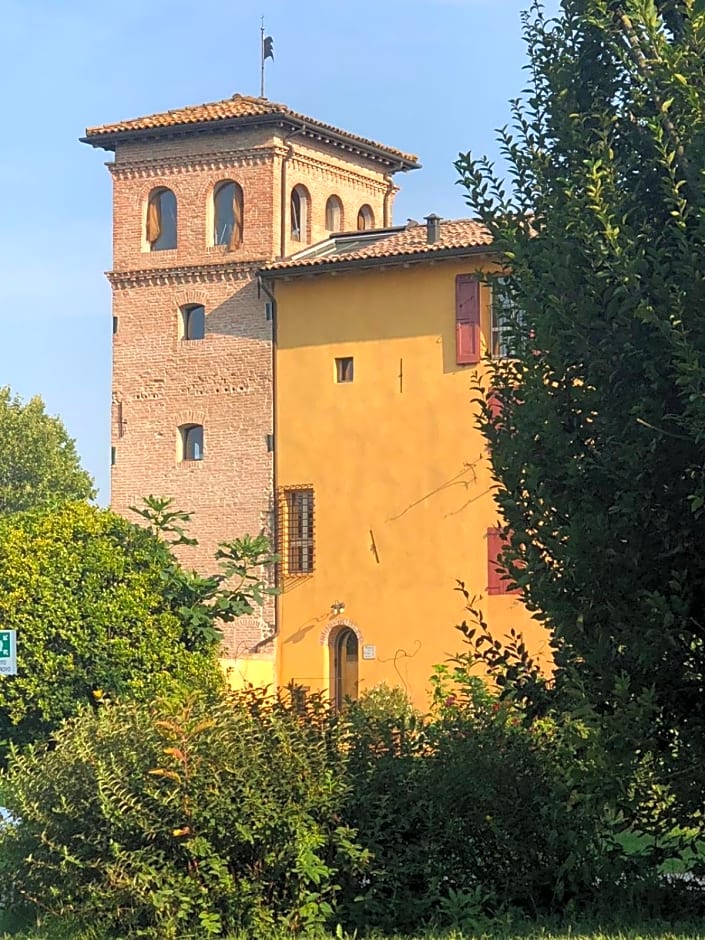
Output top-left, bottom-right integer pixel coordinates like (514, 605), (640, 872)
(0, 693), (366, 938)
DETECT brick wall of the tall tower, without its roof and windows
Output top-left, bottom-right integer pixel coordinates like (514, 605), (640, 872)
(109, 115), (396, 657)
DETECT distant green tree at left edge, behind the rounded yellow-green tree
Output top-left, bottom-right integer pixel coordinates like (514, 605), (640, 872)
(0, 387), (95, 514)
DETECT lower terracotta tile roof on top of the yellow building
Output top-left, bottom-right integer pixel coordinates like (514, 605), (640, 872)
(262, 219), (492, 275)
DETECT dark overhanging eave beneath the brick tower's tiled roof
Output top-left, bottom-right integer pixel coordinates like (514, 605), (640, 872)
(79, 112), (421, 173)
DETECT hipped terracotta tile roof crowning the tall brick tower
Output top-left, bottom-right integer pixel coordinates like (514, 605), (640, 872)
(84, 95), (418, 169)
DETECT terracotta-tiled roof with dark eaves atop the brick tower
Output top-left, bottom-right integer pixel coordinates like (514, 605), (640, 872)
(81, 94), (420, 172)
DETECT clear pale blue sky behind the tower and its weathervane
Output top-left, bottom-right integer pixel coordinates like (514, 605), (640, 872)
(0, 0), (557, 503)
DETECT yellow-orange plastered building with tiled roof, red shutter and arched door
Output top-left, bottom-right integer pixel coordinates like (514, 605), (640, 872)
(261, 216), (546, 705)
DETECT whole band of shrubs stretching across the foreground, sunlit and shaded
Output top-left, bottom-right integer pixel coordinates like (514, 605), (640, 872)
(0, 672), (697, 940)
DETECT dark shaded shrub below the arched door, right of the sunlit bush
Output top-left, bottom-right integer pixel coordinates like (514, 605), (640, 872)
(340, 676), (607, 931)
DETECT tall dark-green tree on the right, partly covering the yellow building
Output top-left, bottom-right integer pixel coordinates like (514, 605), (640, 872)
(456, 0), (705, 809)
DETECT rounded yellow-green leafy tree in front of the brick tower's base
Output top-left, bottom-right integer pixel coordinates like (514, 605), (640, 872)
(0, 502), (276, 744)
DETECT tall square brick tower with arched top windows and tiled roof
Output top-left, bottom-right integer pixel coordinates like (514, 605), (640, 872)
(83, 95), (418, 660)
